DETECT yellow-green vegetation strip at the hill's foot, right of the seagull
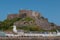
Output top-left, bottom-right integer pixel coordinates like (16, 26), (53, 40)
(17, 25), (45, 32)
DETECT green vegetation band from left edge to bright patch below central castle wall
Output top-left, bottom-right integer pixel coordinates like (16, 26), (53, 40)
(0, 17), (33, 30)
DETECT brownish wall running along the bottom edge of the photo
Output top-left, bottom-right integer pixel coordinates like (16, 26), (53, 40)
(0, 36), (60, 40)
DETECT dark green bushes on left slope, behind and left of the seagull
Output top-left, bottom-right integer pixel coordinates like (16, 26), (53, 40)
(0, 18), (21, 30)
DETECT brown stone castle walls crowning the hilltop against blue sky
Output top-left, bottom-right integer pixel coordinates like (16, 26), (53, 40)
(7, 10), (40, 19)
